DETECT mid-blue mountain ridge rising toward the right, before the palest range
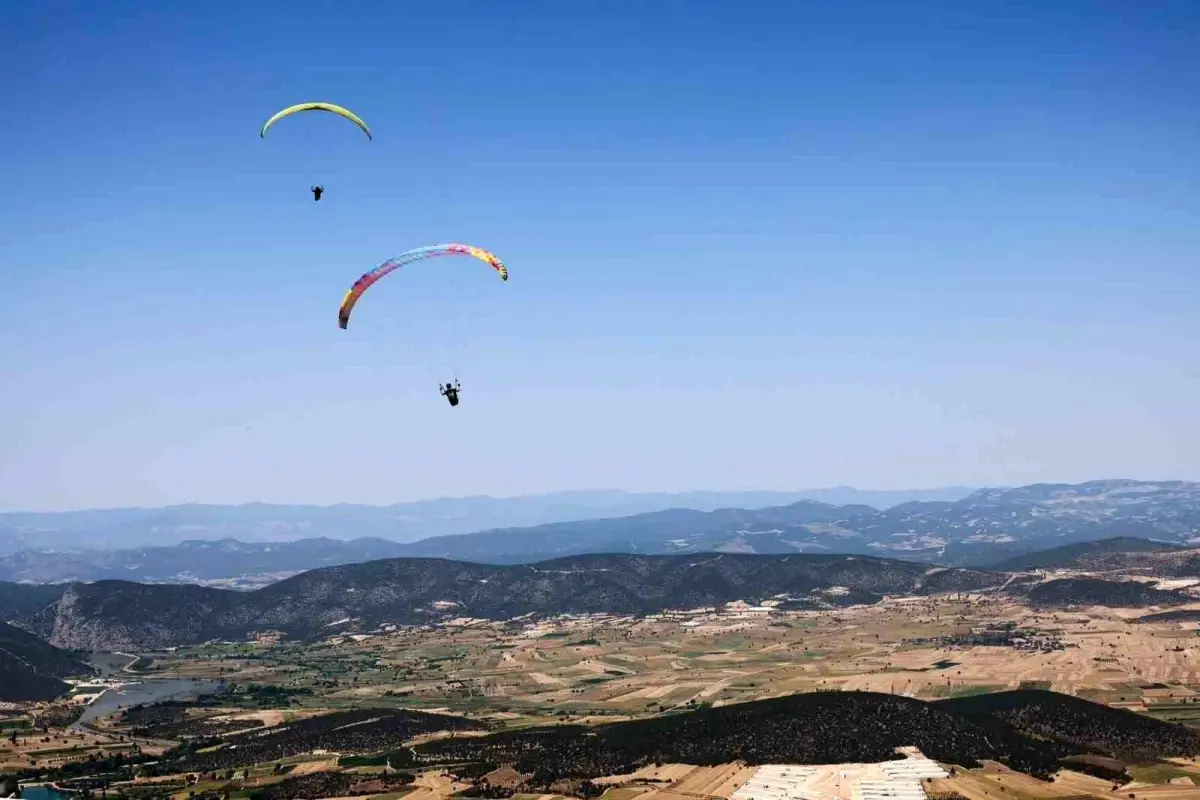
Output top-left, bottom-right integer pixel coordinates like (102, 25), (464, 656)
(393, 480), (1200, 566)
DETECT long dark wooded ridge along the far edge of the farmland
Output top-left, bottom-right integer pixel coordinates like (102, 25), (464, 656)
(28, 553), (1006, 650)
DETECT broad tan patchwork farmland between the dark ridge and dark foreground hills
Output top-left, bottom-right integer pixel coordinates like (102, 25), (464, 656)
(129, 595), (1200, 724)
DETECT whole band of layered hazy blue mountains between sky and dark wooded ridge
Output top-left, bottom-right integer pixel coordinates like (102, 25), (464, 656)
(0, 480), (1200, 588)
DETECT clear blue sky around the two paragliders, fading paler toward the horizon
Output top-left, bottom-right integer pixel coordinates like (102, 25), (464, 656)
(0, 0), (1200, 510)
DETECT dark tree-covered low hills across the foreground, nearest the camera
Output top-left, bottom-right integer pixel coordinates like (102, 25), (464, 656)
(131, 691), (1200, 796)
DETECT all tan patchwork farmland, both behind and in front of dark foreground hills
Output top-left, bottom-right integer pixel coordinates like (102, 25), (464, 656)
(11, 594), (1200, 800)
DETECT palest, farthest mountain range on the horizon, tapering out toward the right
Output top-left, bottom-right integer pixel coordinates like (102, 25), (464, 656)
(0, 487), (972, 554)
